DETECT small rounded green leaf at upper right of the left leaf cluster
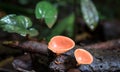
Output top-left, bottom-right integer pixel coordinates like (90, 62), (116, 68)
(16, 15), (32, 28)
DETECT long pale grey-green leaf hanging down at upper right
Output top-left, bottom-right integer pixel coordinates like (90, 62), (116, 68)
(81, 0), (99, 30)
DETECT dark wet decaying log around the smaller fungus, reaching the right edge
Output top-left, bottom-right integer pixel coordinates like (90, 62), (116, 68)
(50, 40), (120, 72)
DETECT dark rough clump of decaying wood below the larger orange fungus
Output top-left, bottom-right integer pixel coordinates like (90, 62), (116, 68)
(49, 55), (76, 72)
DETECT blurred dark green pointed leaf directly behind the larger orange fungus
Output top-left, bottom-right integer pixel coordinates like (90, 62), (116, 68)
(47, 14), (75, 40)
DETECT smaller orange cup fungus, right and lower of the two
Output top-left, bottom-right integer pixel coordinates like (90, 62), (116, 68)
(74, 49), (93, 65)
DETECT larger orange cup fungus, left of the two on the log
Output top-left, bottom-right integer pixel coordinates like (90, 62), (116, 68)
(48, 36), (75, 54)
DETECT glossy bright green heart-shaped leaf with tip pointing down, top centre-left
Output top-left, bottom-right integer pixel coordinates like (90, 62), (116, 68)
(35, 1), (57, 28)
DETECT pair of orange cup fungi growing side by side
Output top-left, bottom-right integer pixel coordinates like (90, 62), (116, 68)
(48, 36), (93, 65)
